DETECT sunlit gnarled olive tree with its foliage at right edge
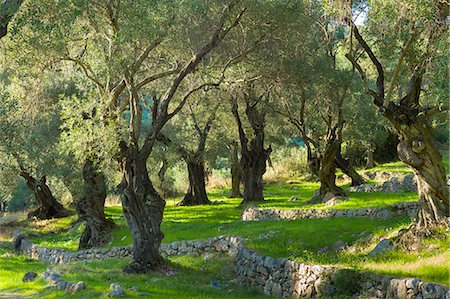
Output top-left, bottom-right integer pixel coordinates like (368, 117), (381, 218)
(346, 1), (450, 247)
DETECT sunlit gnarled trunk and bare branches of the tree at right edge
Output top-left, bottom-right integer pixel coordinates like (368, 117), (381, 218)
(346, 19), (450, 244)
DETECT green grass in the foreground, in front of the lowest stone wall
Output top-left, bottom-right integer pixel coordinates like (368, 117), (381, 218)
(0, 249), (268, 299)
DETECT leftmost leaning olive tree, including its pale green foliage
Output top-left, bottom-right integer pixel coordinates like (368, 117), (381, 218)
(0, 70), (78, 219)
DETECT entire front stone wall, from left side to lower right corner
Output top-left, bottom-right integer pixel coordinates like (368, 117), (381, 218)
(15, 236), (450, 299)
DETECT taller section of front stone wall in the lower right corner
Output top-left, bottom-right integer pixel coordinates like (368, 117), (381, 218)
(236, 249), (450, 299)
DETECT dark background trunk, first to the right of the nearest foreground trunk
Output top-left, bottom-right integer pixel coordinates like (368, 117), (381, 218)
(177, 154), (211, 206)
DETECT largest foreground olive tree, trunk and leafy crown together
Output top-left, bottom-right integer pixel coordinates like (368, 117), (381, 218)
(6, 0), (264, 272)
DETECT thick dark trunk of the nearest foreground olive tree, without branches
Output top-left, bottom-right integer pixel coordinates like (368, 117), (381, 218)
(119, 144), (166, 273)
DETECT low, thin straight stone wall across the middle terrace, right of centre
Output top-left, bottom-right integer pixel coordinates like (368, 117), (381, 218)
(241, 202), (419, 221)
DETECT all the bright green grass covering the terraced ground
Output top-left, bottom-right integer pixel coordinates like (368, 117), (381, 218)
(0, 156), (450, 298)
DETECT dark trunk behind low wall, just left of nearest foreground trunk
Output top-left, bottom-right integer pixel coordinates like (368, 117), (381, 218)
(76, 159), (114, 250)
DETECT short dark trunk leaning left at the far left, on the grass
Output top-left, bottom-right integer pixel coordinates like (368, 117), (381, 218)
(20, 171), (72, 220)
